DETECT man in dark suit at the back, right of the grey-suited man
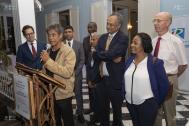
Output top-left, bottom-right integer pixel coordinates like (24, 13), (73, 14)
(83, 22), (97, 114)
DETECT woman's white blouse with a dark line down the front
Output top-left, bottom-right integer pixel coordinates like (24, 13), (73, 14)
(124, 57), (154, 105)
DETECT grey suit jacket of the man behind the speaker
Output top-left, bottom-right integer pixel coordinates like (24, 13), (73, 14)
(72, 40), (85, 76)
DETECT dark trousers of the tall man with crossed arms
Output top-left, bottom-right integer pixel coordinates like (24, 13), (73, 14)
(96, 77), (122, 126)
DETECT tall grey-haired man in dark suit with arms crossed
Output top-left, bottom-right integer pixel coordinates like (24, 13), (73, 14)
(93, 13), (128, 126)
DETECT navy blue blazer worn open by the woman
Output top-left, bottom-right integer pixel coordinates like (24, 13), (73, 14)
(124, 54), (169, 104)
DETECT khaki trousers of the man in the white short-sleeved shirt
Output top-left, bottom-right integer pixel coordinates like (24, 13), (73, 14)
(154, 75), (178, 126)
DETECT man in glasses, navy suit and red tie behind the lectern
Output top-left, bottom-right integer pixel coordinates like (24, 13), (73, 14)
(16, 25), (46, 70)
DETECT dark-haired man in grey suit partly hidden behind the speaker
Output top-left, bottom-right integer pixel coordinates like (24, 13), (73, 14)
(64, 26), (85, 123)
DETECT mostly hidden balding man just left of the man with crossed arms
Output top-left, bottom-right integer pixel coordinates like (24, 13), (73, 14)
(86, 32), (101, 124)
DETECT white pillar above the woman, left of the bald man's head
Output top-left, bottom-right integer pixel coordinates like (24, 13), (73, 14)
(138, 0), (160, 37)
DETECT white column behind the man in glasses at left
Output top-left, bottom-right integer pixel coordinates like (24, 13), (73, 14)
(11, 0), (36, 49)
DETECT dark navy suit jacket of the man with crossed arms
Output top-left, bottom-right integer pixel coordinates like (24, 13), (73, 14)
(93, 31), (128, 90)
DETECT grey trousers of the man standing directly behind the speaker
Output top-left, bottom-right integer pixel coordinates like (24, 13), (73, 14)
(74, 73), (83, 115)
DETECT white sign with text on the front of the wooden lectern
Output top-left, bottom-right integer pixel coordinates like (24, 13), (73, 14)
(14, 75), (31, 120)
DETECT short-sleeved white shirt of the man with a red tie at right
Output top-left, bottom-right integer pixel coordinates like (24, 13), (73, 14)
(152, 32), (187, 74)
